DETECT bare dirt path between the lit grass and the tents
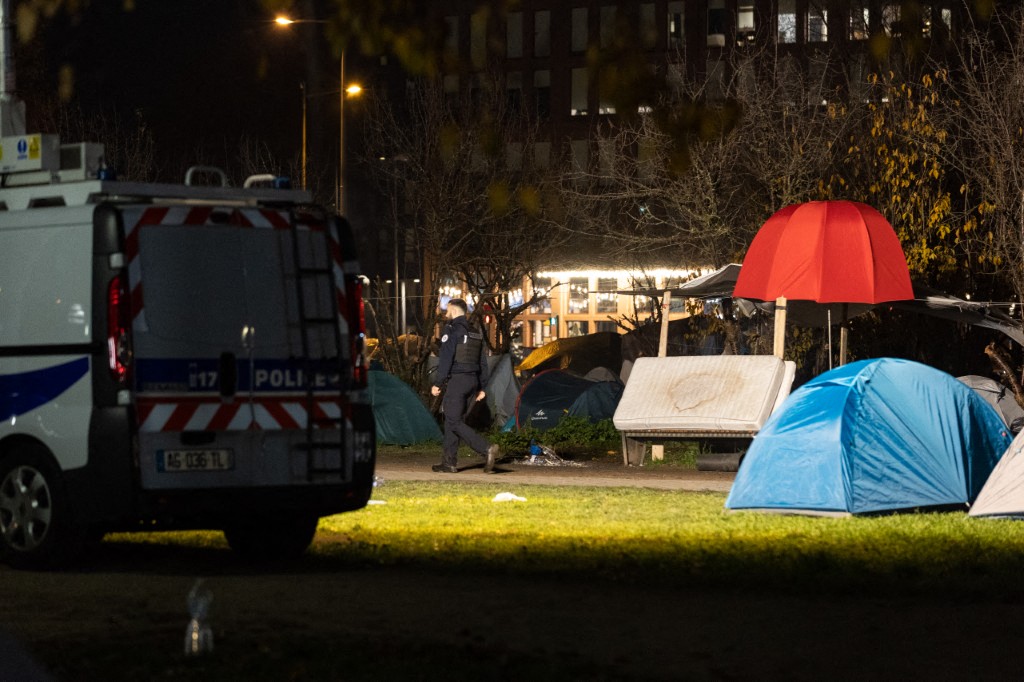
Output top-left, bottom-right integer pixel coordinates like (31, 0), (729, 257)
(377, 453), (735, 493)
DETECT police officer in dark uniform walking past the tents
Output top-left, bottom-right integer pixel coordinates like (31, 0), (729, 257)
(430, 298), (501, 473)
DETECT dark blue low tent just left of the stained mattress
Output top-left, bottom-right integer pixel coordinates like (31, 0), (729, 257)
(515, 370), (623, 431)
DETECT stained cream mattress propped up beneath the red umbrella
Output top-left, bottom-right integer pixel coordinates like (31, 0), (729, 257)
(612, 355), (796, 435)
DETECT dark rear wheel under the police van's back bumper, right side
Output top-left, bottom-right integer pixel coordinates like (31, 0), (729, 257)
(224, 513), (319, 561)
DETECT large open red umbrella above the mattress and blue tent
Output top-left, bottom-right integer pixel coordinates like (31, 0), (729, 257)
(732, 201), (913, 303)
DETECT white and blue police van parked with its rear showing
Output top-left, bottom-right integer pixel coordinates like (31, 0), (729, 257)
(0, 134), (376, 566)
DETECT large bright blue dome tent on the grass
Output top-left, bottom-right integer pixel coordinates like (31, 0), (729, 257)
(725, 358), (1012, 515)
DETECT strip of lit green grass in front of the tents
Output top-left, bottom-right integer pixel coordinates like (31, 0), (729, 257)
(314, 481), (1024, 593)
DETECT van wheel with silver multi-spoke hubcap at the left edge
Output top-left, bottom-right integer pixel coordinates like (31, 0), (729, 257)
(0, 442), (83, 568)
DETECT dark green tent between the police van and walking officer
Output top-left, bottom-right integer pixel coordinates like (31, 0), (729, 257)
(368, 370), (441, 445)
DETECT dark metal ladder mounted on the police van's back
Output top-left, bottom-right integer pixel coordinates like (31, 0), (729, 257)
(290, 211), (351, 481)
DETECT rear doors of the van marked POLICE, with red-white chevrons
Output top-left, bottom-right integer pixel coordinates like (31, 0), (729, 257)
(124, 206), (351, 489)
